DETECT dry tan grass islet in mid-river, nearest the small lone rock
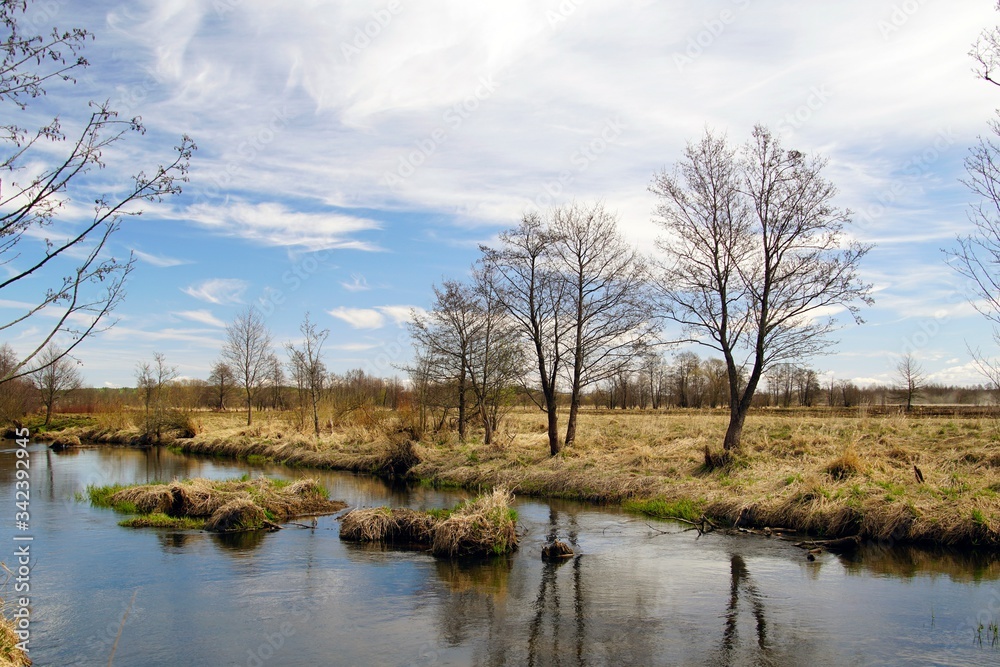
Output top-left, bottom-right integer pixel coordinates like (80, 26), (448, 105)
(340, 489), (517, 558)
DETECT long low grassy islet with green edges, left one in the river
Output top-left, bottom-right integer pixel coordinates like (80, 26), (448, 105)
(87, 477), (346, 533)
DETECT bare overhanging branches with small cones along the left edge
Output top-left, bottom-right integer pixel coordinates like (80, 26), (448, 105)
(0, 0), (195, 383)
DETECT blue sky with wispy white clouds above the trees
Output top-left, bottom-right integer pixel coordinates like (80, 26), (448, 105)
(0, 0), (1000, 386)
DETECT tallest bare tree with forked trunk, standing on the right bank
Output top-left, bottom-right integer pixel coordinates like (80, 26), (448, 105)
(650, 126), (872, 452)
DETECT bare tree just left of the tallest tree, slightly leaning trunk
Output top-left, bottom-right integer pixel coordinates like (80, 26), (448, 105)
(550, 202), (653, 446)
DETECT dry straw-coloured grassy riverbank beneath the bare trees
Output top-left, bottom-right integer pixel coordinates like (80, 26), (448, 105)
(35, 412), (1000, 547)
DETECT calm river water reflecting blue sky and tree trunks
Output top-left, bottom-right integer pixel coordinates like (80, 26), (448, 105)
(0, 441), (1000, 667)
